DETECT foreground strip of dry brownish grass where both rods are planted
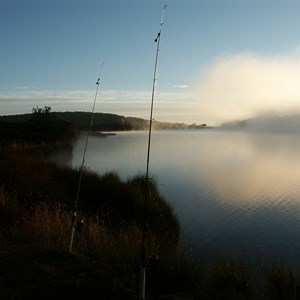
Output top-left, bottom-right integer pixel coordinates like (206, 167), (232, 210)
(0, 182), (300, 299)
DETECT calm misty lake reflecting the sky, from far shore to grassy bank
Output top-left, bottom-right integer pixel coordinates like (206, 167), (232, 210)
(54, 129), (300, 266)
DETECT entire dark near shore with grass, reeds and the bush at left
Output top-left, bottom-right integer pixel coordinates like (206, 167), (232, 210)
(0, 107), (300, 300)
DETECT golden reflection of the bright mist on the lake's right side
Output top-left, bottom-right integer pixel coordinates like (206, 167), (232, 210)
(199, 133), (300, 206)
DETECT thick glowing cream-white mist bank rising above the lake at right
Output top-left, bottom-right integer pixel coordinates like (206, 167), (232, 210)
(194, 48), (300, 125)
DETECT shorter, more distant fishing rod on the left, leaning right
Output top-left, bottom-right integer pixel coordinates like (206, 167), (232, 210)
(69, 62), (104, 252)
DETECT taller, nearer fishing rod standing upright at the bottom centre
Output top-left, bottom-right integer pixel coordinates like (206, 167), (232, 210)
(139, 5), (167, 299)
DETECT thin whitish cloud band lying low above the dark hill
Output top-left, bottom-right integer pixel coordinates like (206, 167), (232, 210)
(0, 89), (197, 123)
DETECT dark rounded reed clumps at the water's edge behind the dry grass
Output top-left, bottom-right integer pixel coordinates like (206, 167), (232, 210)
(0, 154), (180, 239)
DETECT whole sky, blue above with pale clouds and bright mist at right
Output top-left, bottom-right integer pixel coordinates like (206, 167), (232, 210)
(0, 0), (300, 125)
